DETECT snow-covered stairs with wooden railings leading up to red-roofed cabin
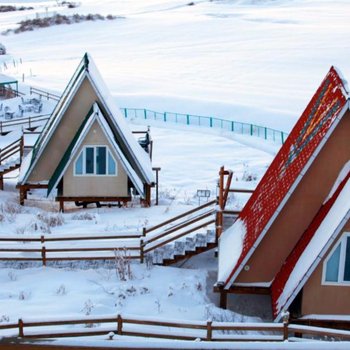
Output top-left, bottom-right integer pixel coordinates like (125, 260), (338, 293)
(142, 200), (217, 265)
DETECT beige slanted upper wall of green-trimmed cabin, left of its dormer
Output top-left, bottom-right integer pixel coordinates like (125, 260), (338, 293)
(27, 78), (98, 183)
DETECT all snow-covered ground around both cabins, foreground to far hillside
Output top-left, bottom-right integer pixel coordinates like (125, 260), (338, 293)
(0, 0), (350, 349)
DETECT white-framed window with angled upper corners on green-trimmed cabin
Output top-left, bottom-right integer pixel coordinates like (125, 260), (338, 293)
(74, 146), (117, 176)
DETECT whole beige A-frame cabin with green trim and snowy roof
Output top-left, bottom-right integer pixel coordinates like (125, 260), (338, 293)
(17, 54), (154, 210)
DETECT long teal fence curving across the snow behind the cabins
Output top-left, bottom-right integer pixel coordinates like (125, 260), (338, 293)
(122, 108), (288, 144)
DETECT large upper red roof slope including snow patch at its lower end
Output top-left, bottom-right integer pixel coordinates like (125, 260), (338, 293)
(218, 67), (348, 288)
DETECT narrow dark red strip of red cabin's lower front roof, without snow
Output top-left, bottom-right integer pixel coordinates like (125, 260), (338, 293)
(271, 172), (350, 318)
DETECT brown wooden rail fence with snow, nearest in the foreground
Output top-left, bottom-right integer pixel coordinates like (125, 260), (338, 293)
(0, 315), (350, 342)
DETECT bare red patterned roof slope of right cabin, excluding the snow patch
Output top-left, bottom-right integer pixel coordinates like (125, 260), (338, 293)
(225, 67), (347, 285)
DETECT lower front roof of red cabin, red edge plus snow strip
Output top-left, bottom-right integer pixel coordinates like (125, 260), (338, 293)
(271, 168), (350, 320)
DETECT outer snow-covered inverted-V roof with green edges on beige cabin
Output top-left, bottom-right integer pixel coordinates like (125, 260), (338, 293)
(22, 54), (154, 185)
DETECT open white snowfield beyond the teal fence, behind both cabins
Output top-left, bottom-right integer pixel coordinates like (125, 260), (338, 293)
(0, 0), (350, 131)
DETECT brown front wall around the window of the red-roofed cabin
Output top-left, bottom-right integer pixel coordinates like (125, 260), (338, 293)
(301, 222), (350, 315)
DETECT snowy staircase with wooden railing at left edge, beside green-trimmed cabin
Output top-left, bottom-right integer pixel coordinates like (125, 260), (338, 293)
(0, 136), (24, 190)
